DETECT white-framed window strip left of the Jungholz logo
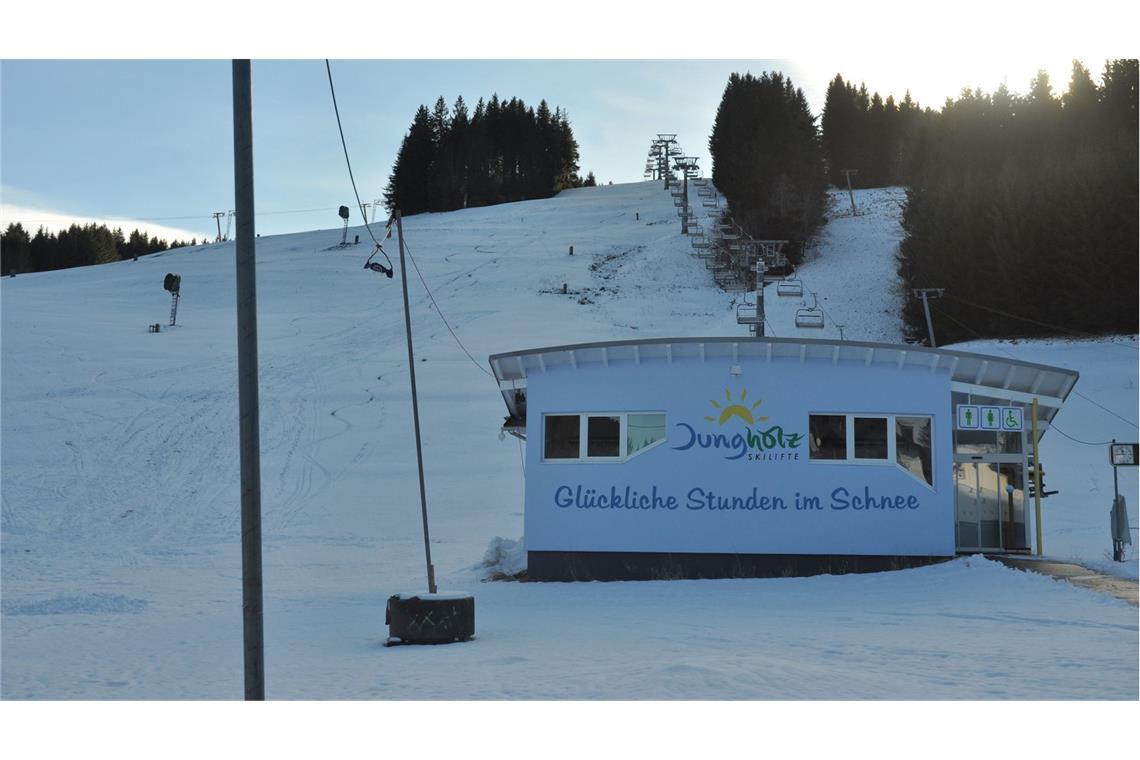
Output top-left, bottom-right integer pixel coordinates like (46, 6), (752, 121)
(543, 411), (666, 461)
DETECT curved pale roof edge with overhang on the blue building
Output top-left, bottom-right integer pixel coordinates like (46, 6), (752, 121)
(489, 337), (1080, 437)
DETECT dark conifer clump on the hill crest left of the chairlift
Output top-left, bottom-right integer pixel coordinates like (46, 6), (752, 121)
(384, 95), (594, 215)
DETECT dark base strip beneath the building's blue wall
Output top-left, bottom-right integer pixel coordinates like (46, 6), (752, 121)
(527, 551), (953, 581)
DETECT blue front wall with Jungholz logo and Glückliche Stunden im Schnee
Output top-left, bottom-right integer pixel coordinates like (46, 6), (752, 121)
(526, 358), (954, 556)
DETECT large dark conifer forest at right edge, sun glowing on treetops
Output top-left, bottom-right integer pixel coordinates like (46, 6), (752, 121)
(898, 59), (1140, 343)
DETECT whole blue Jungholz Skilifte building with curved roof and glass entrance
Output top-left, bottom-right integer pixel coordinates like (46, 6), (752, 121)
(490, 337), (1077, 580)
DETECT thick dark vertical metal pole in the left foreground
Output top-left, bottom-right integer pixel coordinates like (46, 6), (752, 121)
(234, 60), (266, 700)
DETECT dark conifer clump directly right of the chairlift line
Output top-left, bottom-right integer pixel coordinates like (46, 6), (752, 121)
(709, 72), (827, 263)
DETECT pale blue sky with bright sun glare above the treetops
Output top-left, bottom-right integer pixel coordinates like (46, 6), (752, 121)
(0, 26), (1130, 239)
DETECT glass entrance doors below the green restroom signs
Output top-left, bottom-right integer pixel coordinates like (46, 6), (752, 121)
(954, 460), (1029, 551)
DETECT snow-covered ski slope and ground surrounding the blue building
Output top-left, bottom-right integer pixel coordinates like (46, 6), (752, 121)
(0, 183), (1137, 698)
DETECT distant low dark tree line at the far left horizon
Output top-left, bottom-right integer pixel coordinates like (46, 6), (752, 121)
(0, 222), (197, 275)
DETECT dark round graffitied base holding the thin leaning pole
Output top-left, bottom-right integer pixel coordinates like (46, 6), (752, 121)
(384, 593), (475, 646)
